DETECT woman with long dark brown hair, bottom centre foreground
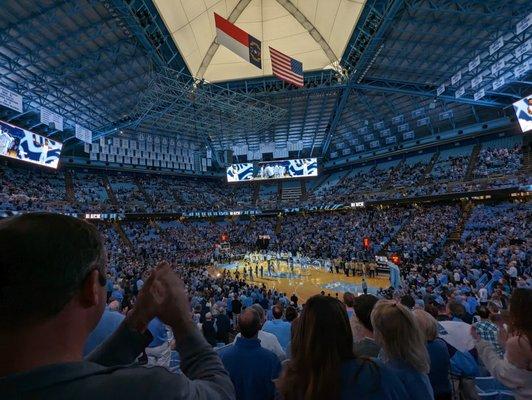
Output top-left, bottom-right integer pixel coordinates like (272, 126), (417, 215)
(276, 295), (408, 400)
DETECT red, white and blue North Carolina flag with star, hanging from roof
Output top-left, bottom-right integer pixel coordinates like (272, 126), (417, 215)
(214, 13), (262, 69)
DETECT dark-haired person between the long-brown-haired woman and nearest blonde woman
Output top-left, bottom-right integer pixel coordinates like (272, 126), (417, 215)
(350, 294), (381, 357)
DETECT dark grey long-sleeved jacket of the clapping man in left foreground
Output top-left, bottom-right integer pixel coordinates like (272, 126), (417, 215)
(0, 323), (234, 400)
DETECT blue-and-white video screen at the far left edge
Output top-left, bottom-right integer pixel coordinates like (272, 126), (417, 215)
(0, 121), (63, 168)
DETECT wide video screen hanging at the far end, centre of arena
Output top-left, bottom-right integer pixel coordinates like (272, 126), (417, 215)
(227, 158), (318, 182)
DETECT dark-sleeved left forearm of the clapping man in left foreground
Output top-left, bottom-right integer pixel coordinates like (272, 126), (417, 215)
(85, 319), (153, 367)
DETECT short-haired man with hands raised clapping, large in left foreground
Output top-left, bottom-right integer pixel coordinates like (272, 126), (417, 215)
(0, 213), (234, 400)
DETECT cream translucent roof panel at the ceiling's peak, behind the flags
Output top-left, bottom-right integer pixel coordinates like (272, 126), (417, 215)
(154, 0), (365, 82)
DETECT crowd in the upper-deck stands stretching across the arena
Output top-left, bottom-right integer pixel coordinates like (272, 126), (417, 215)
(0, 144), (532, 213)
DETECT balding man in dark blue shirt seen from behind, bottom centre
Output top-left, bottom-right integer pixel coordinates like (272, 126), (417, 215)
(219, 308), (281, 400)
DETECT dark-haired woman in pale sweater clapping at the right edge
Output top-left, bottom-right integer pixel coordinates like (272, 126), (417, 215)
(471, 288), (532, 400)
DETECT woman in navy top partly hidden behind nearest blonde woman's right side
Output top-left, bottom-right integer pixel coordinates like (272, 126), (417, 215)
(413, 310), (452, 400)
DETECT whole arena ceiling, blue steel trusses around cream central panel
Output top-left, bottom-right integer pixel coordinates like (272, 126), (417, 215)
(0, 0), (532, 166)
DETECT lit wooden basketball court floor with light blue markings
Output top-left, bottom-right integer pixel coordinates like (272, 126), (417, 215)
(212, 262), (390, 301)
